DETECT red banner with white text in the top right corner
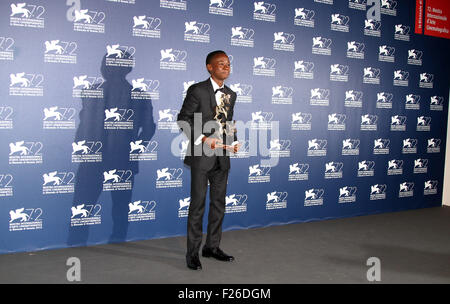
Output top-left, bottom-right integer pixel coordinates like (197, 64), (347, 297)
(424, 0), (450, 39)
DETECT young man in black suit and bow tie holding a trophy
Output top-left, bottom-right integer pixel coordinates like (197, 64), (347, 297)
(177, 51), (240, 270)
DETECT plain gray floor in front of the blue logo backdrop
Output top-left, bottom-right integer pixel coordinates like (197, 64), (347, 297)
(0, 207), (450, 284)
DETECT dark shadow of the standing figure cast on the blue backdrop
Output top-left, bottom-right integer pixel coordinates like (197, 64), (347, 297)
(67, 53), (156, 246)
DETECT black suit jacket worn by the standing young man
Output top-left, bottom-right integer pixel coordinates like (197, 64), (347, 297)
(177, 78), (237, 170)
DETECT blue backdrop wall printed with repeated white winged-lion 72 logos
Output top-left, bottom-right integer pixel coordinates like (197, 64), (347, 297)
(0, 0), (449, 253)
